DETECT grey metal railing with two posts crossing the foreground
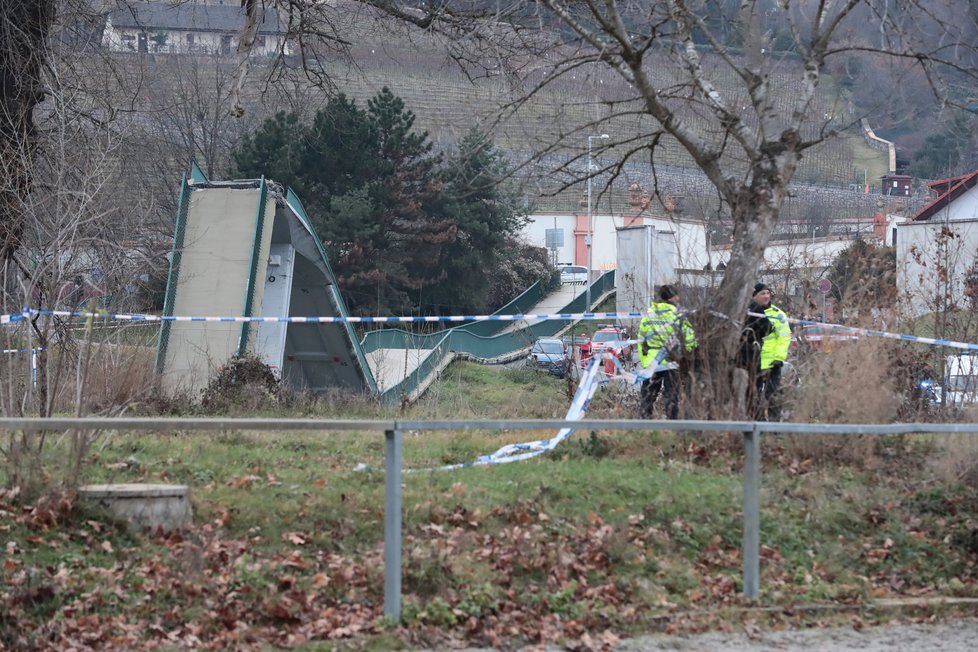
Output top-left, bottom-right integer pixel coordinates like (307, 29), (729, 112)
(0, 417), (978, 619)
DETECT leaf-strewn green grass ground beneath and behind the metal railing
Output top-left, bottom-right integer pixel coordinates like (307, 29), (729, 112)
(0, 363), (978, 649)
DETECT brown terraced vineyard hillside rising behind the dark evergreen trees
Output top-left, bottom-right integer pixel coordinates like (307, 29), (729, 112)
(78, 5), (886, 220)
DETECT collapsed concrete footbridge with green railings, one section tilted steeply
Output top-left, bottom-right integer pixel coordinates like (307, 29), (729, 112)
(156, 165), (614, 402)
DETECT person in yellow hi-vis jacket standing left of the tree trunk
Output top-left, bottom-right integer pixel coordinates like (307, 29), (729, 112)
(638, 285), (696, 419)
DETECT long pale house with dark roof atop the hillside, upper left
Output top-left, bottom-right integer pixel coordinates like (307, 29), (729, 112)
(102, 0), (288, 56)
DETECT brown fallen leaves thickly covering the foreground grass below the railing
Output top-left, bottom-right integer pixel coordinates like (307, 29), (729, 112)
(0, 492), (976, 651)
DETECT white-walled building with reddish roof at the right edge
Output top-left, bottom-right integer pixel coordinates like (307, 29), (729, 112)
(893, 170), (978, 315)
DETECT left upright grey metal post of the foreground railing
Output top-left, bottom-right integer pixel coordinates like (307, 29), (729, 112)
(384, 430), (402, 620)
